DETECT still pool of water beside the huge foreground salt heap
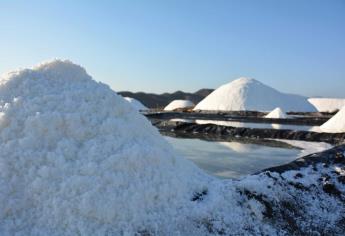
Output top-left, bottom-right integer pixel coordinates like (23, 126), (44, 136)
(165, 137), (300, 178)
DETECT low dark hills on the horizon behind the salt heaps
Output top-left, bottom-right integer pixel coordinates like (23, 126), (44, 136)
(118, 89), (213, 108)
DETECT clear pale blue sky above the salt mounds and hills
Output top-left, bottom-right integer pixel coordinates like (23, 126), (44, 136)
(0, 0), (345, 97)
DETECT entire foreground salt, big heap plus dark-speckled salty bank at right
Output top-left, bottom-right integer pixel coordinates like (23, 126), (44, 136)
(0, 60), (345, 236)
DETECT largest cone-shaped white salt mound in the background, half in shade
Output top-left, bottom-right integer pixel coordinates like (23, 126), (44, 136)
(194, 77), (316, 112)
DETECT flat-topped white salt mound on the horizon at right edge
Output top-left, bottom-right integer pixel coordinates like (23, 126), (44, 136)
(308, 98), (345, 112)
